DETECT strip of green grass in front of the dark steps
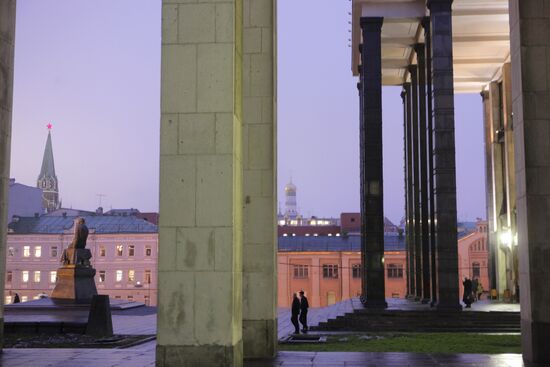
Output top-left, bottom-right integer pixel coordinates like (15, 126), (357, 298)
(279, 333), (521, 354)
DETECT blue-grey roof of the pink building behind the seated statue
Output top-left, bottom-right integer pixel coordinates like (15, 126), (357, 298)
(8, 215), (158, 234)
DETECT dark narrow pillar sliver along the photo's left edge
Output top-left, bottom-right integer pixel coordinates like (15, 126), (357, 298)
(0, 0), (16, 346)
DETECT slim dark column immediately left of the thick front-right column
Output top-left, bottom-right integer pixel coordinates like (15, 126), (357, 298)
(422, 17), (437, 307)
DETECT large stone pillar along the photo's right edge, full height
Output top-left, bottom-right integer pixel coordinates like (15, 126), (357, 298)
(510, 0), (550, 365)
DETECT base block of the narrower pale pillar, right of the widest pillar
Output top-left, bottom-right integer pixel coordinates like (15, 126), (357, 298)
(243, 319), (277, 358)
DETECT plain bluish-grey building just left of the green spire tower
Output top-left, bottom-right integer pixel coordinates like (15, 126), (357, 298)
(8, 178), (44, 222)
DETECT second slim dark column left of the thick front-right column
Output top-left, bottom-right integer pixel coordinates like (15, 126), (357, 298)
(414, 43), (431, 303)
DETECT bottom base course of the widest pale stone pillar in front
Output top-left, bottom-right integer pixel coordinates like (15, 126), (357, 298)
(156, 340), (243, 367)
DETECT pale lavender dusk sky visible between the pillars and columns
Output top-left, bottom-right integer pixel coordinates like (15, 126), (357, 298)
(7, 0), (485, 223)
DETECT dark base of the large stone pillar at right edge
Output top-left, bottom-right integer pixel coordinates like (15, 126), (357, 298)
(521, 319), (550, 366)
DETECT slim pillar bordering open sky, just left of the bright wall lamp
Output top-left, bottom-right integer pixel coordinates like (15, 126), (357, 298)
(481, 91), (497, 291)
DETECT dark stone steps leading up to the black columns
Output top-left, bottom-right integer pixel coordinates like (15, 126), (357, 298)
(311, 308), (521, 333)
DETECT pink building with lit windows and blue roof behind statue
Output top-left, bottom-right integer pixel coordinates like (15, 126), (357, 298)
(4, 214), (158, 305)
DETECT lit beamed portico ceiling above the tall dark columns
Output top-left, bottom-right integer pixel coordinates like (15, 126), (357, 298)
(351, 0), (510, 93)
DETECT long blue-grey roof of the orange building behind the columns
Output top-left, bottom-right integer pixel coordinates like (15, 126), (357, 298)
(279, 236), (405, 252)
